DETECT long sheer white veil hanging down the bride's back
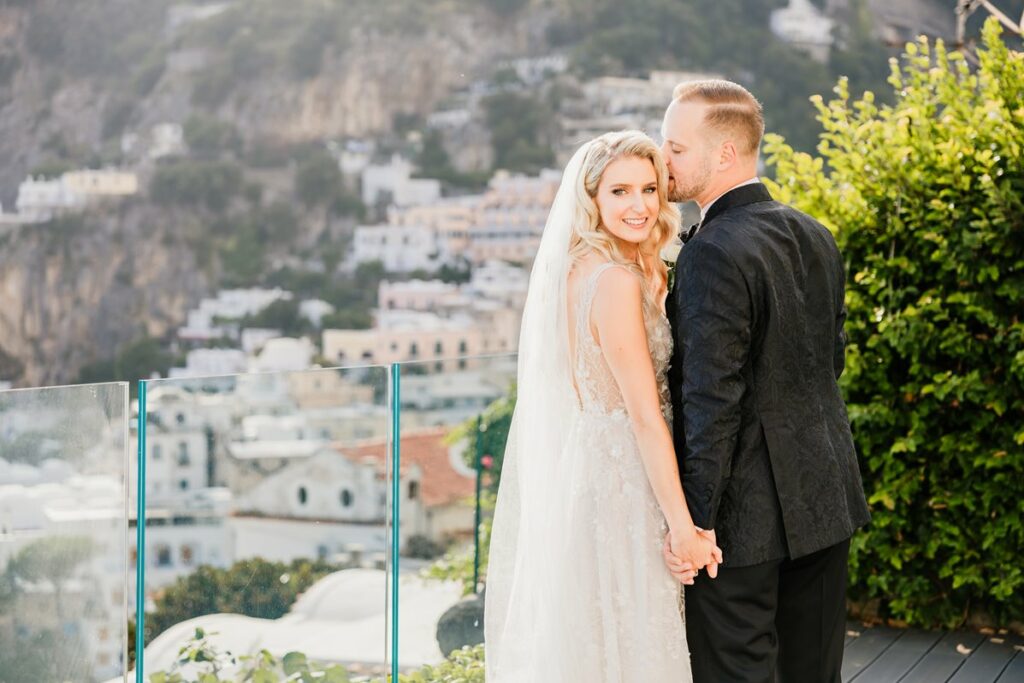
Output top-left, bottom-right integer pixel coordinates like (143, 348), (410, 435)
(484, 142), (593, 683)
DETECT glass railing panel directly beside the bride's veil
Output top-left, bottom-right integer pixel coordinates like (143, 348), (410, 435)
(393, 355), (516, 674)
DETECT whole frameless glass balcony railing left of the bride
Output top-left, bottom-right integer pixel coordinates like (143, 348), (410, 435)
(0, 355), (515, 683)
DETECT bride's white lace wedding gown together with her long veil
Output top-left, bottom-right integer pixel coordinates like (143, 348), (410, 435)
(484, 142), (692, 683)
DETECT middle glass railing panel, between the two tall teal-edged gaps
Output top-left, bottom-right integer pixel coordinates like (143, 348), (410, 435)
(139, 367), (391, 681)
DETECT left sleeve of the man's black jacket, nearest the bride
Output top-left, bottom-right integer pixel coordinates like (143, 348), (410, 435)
(676, 241), (753, 528)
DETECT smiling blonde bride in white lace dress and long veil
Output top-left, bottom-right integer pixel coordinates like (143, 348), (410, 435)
(484, 131), (722, 683)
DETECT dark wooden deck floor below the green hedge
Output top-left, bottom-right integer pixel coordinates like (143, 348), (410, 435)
(843, 623), (1024, 683)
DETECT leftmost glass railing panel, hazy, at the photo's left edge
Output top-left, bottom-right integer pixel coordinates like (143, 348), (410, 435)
(0, 383), (129, 683)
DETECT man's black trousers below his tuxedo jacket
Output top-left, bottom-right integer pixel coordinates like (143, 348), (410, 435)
(686, 539), (850, 683)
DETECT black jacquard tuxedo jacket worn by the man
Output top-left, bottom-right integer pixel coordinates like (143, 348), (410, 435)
(667, 183), (869, 566)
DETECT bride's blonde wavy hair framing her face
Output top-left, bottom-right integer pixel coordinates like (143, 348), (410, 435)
(569, 130), (679, 293)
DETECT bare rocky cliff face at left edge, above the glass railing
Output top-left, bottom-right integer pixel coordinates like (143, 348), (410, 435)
(0, 206), (207, 386)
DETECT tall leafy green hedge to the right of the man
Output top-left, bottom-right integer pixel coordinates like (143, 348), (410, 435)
(766, 19), (1024, 626)
